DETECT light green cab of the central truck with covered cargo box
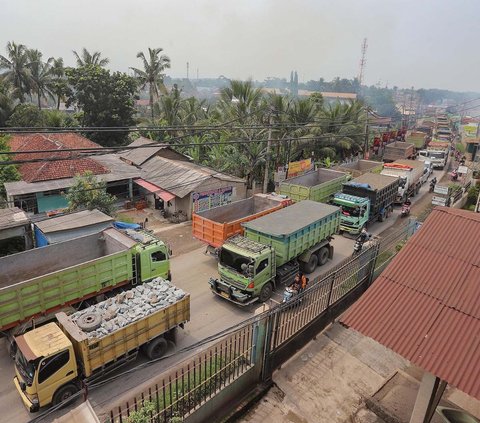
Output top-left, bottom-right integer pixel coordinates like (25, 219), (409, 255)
(210, 235), (276, 305)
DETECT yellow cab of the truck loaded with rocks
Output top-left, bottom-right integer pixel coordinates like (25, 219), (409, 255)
(14, 323), (79, 412)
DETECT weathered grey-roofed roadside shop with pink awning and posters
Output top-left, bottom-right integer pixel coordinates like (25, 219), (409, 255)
(119, 138), (246, 219)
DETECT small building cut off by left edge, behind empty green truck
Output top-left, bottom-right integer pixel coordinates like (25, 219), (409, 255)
(0, 207), (33, 256)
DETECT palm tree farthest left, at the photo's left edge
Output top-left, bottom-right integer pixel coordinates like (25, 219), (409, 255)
(0, 41), (31, 103)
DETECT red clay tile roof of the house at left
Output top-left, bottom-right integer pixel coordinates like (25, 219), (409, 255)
(9, 133), (110, 182)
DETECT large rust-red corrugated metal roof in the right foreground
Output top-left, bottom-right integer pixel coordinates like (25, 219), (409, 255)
(341, 207), (480, 399)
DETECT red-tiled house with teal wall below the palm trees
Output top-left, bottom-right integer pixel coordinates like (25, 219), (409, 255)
(5, 133), (140, 214)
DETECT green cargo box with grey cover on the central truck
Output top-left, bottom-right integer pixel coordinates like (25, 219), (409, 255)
(243, 200), (340, 266)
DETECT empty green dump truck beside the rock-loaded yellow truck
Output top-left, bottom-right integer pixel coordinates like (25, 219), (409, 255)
(0, 228), (171, 339)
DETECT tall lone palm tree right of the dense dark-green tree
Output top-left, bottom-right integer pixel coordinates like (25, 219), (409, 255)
(130, 47), (170, 120)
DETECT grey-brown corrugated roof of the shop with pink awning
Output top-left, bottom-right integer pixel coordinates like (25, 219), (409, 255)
(142, 156), (244, 198)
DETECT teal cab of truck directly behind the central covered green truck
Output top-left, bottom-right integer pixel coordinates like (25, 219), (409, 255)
(333, 193), (370, 234)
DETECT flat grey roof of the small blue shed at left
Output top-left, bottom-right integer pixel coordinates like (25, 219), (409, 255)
(35, 209), (113, 234)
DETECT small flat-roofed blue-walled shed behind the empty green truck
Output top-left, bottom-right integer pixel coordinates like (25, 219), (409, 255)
(33, 209), (113, 247)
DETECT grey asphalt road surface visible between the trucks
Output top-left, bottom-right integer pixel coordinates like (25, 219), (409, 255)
(0, 171), (444, 423)
